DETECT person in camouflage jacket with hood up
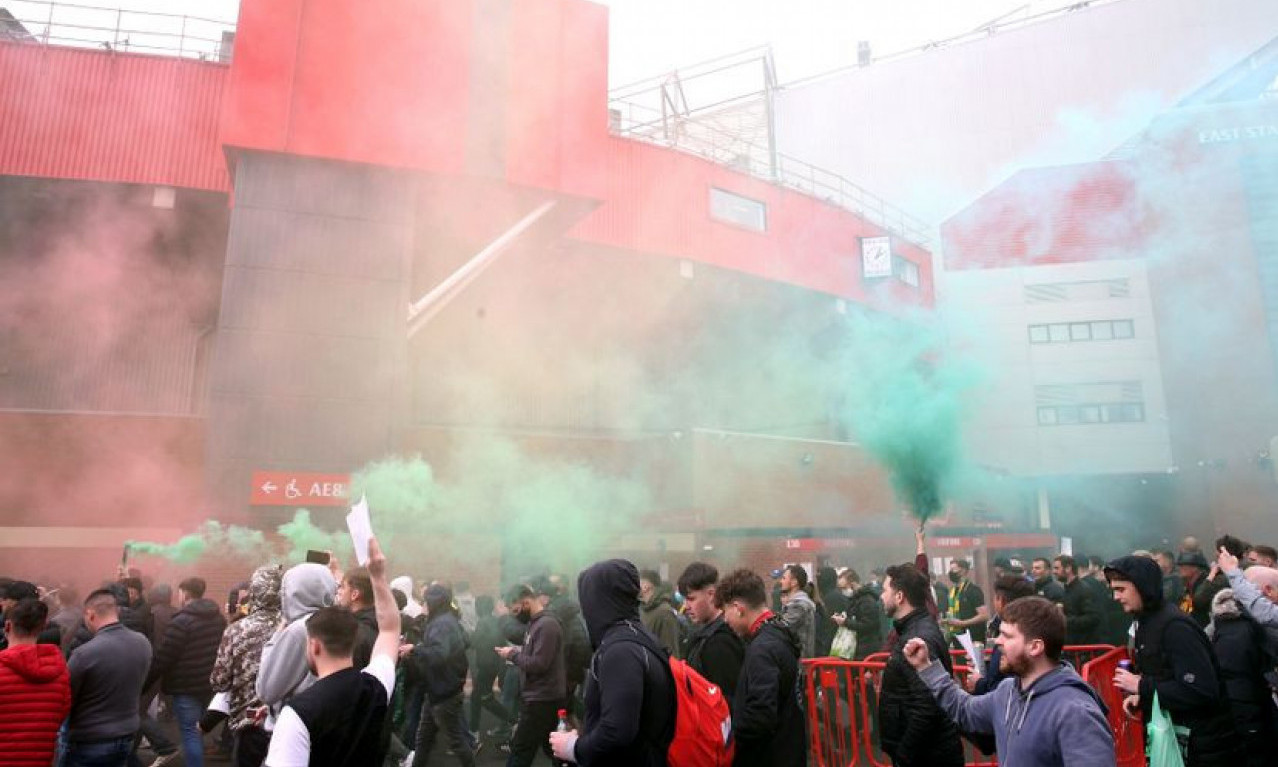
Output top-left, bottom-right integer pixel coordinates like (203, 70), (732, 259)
(210, 565), (284, 767)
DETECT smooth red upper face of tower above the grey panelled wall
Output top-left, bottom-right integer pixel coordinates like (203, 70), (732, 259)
(222, 0), (478, 173)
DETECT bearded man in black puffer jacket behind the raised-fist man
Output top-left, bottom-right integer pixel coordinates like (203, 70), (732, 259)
(879, 564), (964, 767)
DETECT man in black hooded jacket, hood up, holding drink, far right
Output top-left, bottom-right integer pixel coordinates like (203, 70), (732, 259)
(1105, 556), (1245, 767)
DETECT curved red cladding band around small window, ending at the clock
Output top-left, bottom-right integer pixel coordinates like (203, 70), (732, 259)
(569, 138), (933, 306)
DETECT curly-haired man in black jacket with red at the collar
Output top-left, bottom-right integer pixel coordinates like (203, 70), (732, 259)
(714, 570), (808, 767)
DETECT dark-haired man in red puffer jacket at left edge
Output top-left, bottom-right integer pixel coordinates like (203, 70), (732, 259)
(0, 600), (72, 767)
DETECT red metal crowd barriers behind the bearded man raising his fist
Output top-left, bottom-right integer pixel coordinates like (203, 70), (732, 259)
(803, 644), (1145, 767)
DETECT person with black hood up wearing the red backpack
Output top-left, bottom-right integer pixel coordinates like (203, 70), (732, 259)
(551, 560), (676, 767)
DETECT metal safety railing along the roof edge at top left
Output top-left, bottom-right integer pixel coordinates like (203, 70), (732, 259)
(0, 0), (235, 63)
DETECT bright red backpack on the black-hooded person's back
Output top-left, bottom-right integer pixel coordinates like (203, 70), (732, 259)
(666, 657), (736, 767)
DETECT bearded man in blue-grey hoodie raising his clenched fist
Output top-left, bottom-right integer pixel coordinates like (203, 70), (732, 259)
(905, 597), (1116, 767)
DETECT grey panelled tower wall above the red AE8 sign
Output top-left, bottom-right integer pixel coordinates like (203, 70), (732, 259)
(207, 152), (414, 509)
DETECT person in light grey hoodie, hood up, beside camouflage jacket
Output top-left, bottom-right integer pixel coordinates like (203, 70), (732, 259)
(257, 562), (337, 713)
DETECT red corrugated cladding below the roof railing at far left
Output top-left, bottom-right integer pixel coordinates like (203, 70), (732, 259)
(0, 42), (229, 190)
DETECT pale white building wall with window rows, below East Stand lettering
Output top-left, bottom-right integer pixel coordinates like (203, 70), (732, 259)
(943, 260), (1173, 476)
